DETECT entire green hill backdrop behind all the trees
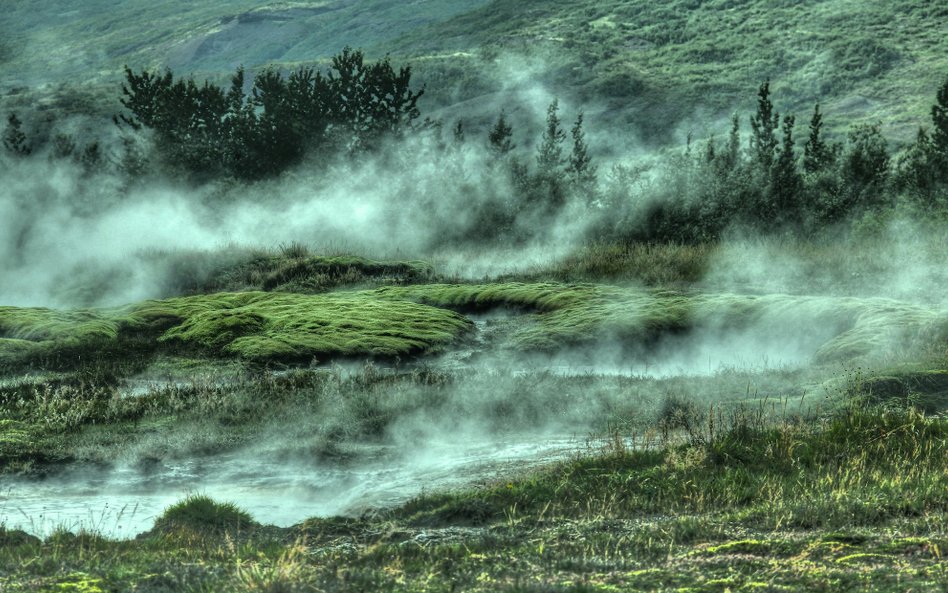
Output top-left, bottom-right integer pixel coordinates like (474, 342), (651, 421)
(0, 0), (948, 143)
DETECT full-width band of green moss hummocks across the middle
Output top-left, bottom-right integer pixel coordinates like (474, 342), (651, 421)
(0, 282), (948, 364)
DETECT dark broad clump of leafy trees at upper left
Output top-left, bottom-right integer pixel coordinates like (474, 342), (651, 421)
(117, 48), (424, 180)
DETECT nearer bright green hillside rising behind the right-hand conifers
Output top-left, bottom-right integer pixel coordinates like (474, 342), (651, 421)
(396, 0), (948, 136)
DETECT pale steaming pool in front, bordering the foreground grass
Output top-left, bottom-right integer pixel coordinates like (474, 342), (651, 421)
(0, 435), (579, 538)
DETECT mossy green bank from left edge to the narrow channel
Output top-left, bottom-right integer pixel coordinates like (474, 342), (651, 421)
(0, 292), (471, 366)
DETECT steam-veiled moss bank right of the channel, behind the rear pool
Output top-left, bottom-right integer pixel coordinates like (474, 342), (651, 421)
(375, 282), (948, 362)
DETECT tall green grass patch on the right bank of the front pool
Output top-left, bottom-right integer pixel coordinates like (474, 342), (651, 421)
(400, 407), (948, 529)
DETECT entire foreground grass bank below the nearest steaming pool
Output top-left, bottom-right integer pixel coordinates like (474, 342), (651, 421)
(0, 405), (948, 592)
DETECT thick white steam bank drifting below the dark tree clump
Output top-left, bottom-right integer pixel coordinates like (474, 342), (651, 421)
(0, 117), (600, 307)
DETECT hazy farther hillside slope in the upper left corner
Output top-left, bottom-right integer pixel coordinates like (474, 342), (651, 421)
(0, 0), (482, 85)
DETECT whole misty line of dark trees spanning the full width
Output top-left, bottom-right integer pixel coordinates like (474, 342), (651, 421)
(3, 48), (948, 243)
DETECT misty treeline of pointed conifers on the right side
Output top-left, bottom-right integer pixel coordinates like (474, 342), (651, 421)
(601, 81), (948, 242)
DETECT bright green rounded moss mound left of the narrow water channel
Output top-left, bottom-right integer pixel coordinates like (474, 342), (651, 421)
(130, 292), (471, 361)
